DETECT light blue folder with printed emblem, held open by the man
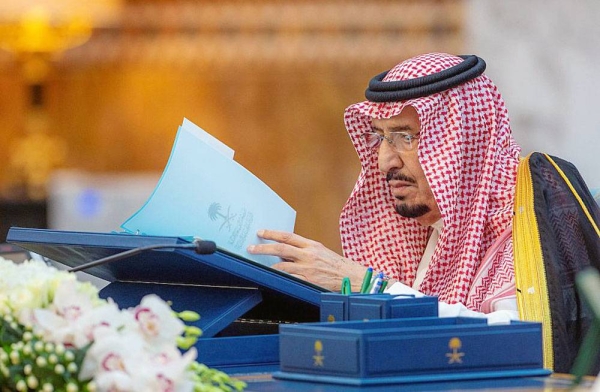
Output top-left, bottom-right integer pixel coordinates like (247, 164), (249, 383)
(121, 120), (296, 266)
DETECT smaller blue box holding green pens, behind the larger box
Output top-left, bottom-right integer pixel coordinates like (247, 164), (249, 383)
(321, 293), (438, 322)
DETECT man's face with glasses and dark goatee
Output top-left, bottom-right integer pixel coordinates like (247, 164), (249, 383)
(372, 106), (441, 226)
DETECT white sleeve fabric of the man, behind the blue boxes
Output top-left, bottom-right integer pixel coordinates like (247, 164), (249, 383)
(385, 282), (519, 325)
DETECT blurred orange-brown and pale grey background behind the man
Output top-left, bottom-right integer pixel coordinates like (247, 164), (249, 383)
(0, 0), (600, 251)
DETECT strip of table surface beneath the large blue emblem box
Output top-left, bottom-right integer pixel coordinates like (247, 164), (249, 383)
(232, 372), (594, 392)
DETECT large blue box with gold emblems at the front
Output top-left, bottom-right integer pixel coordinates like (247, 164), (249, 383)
(274, 317), (550, 385)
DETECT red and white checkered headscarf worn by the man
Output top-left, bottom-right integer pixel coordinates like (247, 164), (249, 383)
(340, 53), (520, 310)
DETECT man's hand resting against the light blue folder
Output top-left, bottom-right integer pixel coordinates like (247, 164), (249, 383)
(248, 230), (367, 291)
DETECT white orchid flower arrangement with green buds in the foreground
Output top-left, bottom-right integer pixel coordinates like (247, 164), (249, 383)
(0, 257), (245, 392)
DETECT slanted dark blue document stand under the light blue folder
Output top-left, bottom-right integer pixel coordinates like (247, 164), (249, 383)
(6, 227), (327, 369)
